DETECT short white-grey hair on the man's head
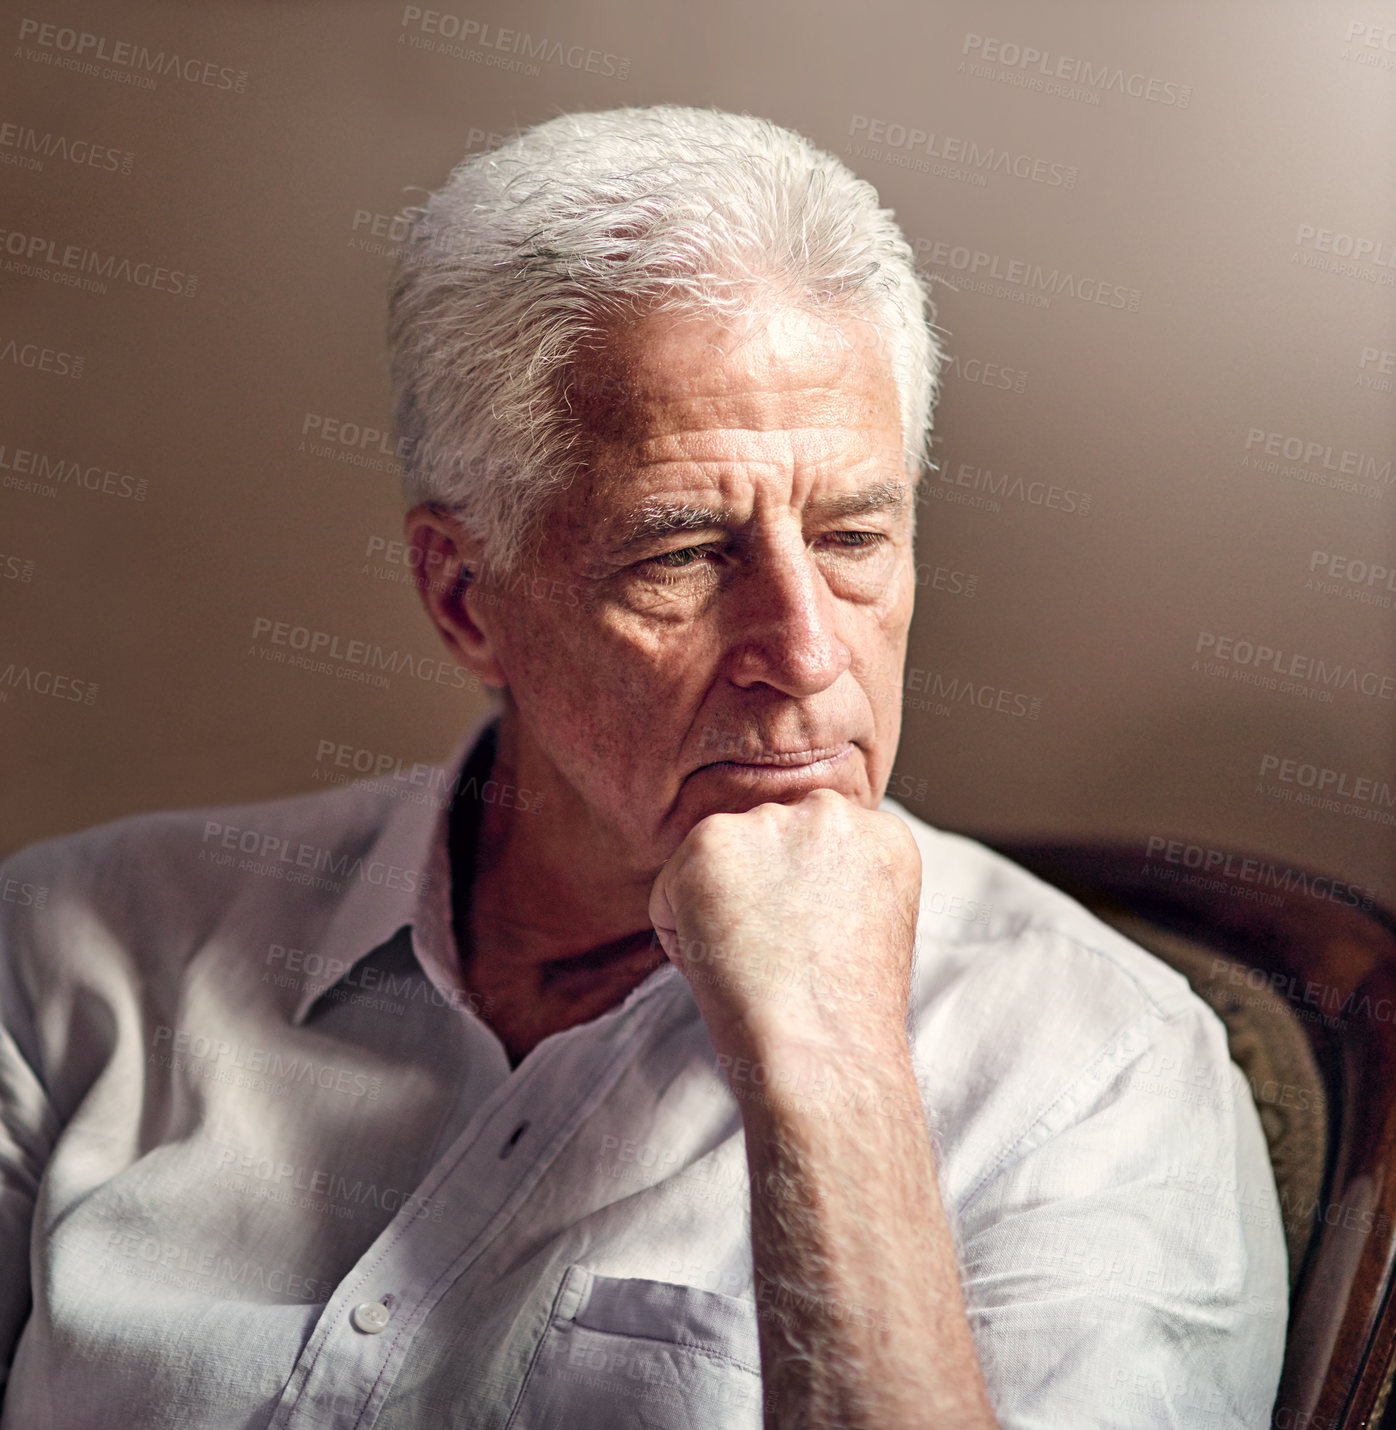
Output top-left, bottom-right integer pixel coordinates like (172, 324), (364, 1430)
(388, 104), (941, 571)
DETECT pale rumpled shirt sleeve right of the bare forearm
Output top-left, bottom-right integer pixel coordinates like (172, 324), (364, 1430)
(958, 1004), (1289, 1430)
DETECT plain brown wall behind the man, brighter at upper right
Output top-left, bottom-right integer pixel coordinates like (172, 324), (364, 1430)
(0, 0), (1396, 902)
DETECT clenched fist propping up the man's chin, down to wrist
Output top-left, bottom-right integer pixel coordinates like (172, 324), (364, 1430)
(649, 789), (921, 1051)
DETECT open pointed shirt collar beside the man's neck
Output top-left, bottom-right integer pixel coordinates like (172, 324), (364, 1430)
(292, 699), (502, 1025)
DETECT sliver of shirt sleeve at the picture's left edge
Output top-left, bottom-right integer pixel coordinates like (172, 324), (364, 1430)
(0, 865), (57, 1401)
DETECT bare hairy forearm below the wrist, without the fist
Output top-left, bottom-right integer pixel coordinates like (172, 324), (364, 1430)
(729, 1038), (996, 1430)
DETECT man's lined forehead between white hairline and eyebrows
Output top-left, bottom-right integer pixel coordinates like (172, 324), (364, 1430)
(559, 307), (904, 526)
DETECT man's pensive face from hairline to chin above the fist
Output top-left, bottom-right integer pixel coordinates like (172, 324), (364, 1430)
(469, 309), (915, 871)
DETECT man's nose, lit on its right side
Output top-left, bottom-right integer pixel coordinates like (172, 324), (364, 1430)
(724, 531), (852, 699)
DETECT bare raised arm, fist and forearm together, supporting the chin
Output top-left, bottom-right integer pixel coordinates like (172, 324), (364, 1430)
(651, 791), (996, 1430)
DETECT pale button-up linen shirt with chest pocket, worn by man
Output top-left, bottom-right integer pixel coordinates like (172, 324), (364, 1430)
(0, 712), (1287, 1430)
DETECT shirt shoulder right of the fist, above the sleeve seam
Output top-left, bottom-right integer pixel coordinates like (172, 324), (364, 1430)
(884, 801), (1233, 1193)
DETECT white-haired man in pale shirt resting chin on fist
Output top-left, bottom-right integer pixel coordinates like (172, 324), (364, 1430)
(0, 107), (1286, 1430)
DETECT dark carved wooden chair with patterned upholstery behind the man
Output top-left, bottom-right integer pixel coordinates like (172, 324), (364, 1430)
(980, 835), (1396, 1430)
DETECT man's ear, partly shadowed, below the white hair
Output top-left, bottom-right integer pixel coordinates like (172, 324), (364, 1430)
(402, 503), (509, 689)
